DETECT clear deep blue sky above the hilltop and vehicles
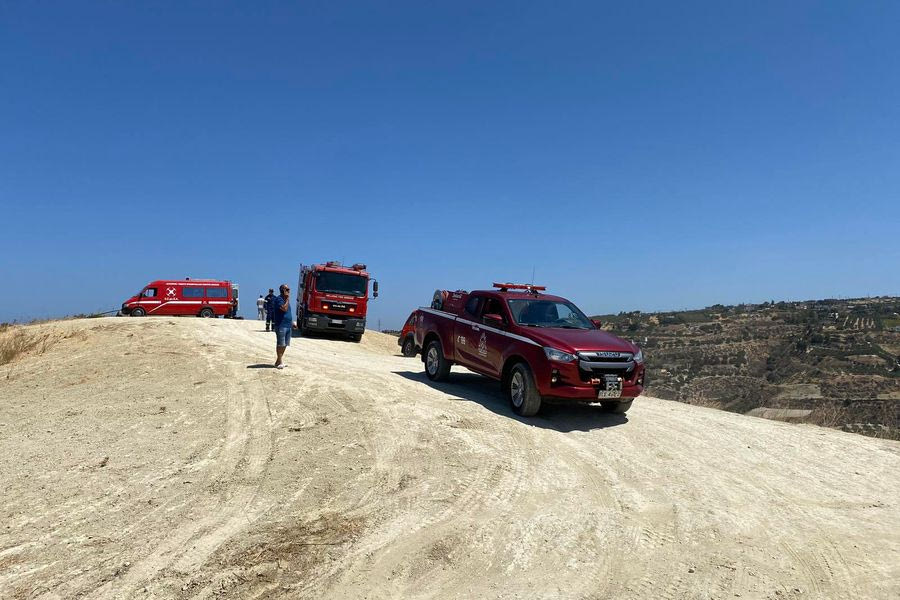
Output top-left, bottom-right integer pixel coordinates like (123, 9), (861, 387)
(0, 1), (900, 328)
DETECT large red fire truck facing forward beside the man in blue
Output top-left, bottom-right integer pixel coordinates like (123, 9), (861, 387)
(297, 261), (378, 342)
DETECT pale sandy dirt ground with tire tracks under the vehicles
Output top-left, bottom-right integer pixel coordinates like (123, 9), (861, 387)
(0, 318), (900, 599)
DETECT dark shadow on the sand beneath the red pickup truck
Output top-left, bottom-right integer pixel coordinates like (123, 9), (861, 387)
(394, 371), (628, 432)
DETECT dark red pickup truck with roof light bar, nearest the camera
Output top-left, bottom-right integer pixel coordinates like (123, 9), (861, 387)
(415, 283), (644, 416)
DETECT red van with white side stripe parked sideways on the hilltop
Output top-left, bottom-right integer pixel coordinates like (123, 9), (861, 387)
(122, 279), (238, 318)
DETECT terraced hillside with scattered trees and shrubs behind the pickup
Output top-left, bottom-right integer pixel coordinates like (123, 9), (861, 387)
(600, 297), (900, 439)
